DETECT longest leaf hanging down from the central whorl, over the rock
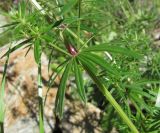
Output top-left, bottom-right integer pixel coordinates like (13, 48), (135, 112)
(55, 61), (72, 119)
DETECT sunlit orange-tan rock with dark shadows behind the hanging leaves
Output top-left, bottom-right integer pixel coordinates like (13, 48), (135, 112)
(0, 42), (102, 133)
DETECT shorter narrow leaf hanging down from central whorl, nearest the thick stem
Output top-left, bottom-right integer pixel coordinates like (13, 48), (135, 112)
(74, 60), (87, 103)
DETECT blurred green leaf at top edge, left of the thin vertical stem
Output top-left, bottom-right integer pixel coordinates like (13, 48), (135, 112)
(60, 0), (77, 15)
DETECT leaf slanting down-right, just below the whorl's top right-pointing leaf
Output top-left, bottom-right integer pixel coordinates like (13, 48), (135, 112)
(79, 53), (120, 77)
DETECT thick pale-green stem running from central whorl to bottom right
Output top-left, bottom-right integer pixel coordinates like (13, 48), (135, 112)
(83, 65), (139, 133)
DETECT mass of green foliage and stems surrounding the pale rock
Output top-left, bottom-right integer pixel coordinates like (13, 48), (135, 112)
(1, 0), (160, 133)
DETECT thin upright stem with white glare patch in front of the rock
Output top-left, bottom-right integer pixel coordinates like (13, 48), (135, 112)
(38, 63), (44, 133)
